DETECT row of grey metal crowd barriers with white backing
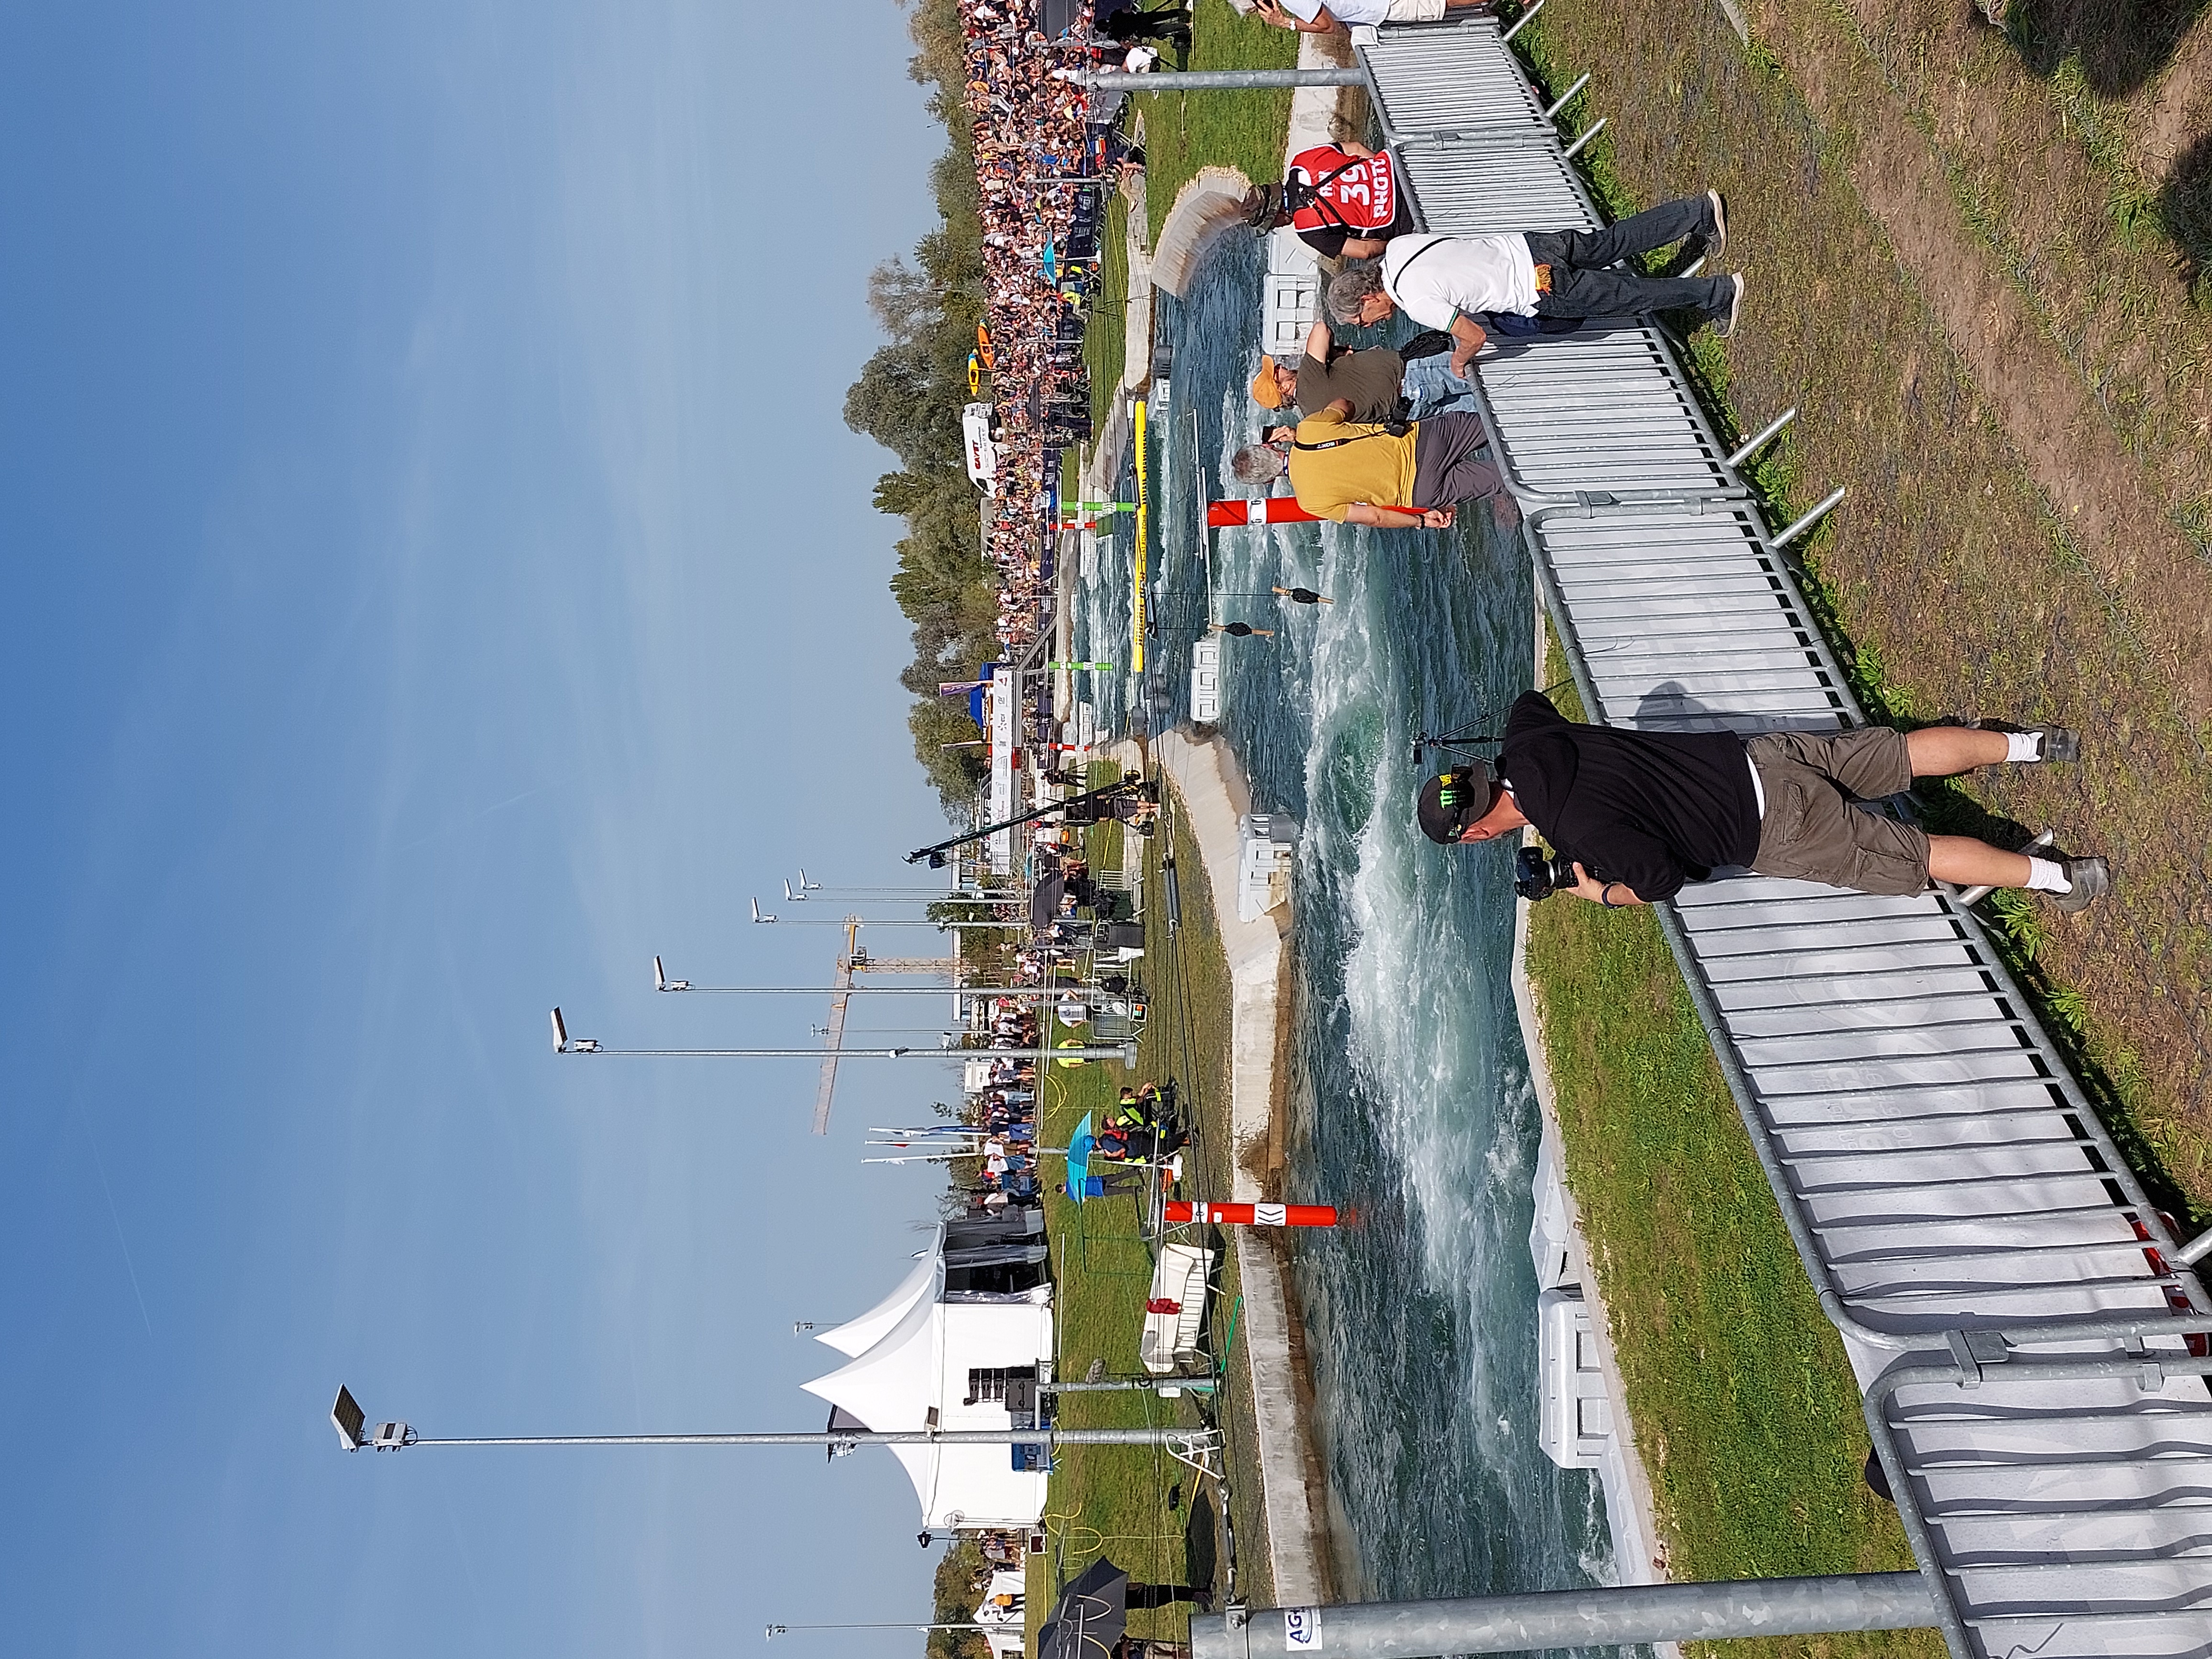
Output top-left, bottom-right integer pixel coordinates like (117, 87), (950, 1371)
(1360, 20), (2212, 1659)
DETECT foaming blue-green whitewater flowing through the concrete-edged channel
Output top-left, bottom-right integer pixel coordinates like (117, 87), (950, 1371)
(1077, 234), (1610, 1628)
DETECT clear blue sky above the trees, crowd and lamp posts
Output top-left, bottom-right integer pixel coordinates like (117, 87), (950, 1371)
(0, 0), (986, 1657)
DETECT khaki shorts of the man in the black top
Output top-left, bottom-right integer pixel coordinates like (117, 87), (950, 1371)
(1743, 726), (1929, 894)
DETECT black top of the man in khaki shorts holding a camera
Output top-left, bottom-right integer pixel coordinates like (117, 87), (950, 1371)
(1497, 692), (1759, 900)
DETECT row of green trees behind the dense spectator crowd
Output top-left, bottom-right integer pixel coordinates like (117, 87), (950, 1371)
(845, 0), (997, 823)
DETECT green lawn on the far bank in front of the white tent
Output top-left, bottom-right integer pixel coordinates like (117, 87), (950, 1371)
(1029, 765), (1265, 1639)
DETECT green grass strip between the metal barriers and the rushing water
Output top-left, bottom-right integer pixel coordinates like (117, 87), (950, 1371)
(1528, 641), (1942, 1655)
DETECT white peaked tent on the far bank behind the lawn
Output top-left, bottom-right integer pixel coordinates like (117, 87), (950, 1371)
(803, 1232), (1053, 1528)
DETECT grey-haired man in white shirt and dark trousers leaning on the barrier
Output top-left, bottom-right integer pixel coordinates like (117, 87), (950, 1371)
(1329, 190), (1743, 376)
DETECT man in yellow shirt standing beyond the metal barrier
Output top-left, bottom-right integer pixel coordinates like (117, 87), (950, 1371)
(1230, 398), (1504, 531)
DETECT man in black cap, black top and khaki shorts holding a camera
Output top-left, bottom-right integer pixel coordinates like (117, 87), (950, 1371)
(1418, 692), (2112, 911)
